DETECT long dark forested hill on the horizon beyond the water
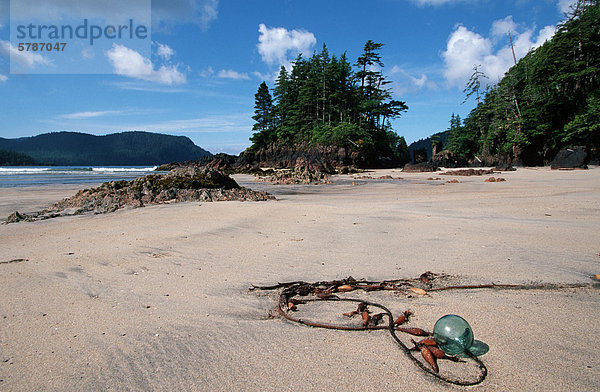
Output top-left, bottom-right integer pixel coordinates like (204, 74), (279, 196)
(0, 131), (211, 166)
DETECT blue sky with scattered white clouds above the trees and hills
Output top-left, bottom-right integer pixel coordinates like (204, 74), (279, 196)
(0, 0), (573, 154)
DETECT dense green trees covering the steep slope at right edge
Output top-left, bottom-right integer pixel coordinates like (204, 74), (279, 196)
(448, 0), (600, 165)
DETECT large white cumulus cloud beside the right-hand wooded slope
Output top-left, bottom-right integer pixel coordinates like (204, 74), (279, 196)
(442, 17), (555, 87)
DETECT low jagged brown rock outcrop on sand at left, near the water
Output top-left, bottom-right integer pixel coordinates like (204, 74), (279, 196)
(6, 165), (274, 223)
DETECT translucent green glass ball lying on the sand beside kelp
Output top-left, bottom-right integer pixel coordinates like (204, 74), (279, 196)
(433, 314), (473, 355)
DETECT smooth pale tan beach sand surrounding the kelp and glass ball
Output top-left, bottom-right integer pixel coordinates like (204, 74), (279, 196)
(0, 167), (600, 391)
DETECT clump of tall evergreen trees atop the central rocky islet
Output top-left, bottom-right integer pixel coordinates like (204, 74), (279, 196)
(250, 41), (408, 165)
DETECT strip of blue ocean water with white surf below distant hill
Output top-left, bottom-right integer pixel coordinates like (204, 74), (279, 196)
(0, 166), (158, 188)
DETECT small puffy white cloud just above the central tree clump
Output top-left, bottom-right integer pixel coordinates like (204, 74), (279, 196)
(257, 23), (317, 65)
